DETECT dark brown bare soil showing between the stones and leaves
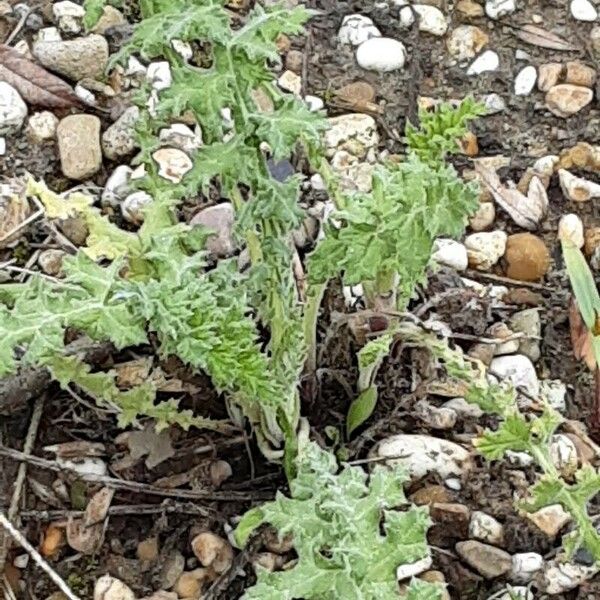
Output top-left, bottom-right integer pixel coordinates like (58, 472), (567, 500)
(0, 0), (600, 600)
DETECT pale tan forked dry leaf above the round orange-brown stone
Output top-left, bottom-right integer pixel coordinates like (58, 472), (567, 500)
(475, 161), (548, 231)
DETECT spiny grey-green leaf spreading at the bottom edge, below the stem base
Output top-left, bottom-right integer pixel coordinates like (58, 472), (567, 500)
(235, 443), (442, 600)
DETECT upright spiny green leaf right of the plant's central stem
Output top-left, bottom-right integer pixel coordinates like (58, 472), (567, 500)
(308, 99), (483, 308)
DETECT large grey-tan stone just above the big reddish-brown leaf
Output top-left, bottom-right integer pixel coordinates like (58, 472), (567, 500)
(32, 33), (108, 81)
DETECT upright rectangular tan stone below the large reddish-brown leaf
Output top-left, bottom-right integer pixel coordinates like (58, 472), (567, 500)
(56, 115), (102, 181)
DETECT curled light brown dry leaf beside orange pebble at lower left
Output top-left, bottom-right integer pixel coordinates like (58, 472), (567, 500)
(67, 488), (115, 554)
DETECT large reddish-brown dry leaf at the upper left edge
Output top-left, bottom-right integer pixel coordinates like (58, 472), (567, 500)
(0, 44), (81, 108)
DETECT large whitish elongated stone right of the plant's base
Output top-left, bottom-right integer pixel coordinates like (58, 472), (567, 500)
(370, 434), (473, 480)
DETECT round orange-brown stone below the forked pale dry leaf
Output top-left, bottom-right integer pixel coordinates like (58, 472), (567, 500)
(504, 233), (550, 281)
